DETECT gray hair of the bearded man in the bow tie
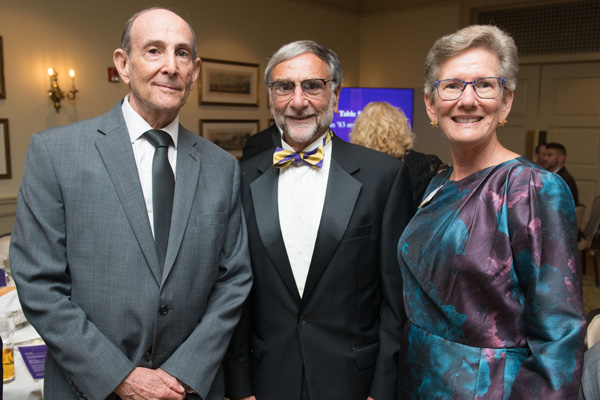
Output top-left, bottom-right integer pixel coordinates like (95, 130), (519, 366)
(265, 40), (344, 92)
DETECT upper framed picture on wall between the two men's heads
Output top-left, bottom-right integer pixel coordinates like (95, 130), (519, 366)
(198, 58), (259, 107)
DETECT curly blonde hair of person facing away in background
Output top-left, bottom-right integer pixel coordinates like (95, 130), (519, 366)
(350, 101), (414, 159)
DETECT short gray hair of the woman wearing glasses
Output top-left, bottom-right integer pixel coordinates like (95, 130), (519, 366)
(424, 25), (519, 98)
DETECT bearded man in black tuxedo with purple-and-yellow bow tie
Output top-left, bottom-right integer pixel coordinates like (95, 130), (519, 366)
(225, 41), (413, 400)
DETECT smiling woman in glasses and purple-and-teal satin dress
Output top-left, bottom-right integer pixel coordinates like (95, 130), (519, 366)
(398, 25), (585, 400)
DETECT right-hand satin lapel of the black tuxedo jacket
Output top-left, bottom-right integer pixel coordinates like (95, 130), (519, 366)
(302, 136), (362, 299)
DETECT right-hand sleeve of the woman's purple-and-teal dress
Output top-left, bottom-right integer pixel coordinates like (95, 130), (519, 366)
(506, 169), (585, 400)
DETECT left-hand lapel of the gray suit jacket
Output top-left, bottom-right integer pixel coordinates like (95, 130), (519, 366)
(96, 103), (161, 282)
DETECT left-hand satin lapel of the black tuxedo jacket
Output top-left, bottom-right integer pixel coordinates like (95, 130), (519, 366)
(250, 153), (300, 303)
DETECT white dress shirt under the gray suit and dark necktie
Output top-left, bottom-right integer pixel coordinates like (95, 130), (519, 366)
(121, 95), (179, 235)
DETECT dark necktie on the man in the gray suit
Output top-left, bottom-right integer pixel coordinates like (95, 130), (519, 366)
(144, 129), (175, 268)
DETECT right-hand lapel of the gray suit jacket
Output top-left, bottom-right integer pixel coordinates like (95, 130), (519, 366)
(162, 130), (202, 283)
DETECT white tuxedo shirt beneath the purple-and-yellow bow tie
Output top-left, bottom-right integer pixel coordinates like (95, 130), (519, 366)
(278, 133), (332, 297)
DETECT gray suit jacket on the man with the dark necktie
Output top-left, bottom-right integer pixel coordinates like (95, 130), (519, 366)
(10, 103), (252, 400)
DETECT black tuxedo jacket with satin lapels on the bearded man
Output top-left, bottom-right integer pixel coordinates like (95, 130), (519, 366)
(225, 136), (413, 400)
